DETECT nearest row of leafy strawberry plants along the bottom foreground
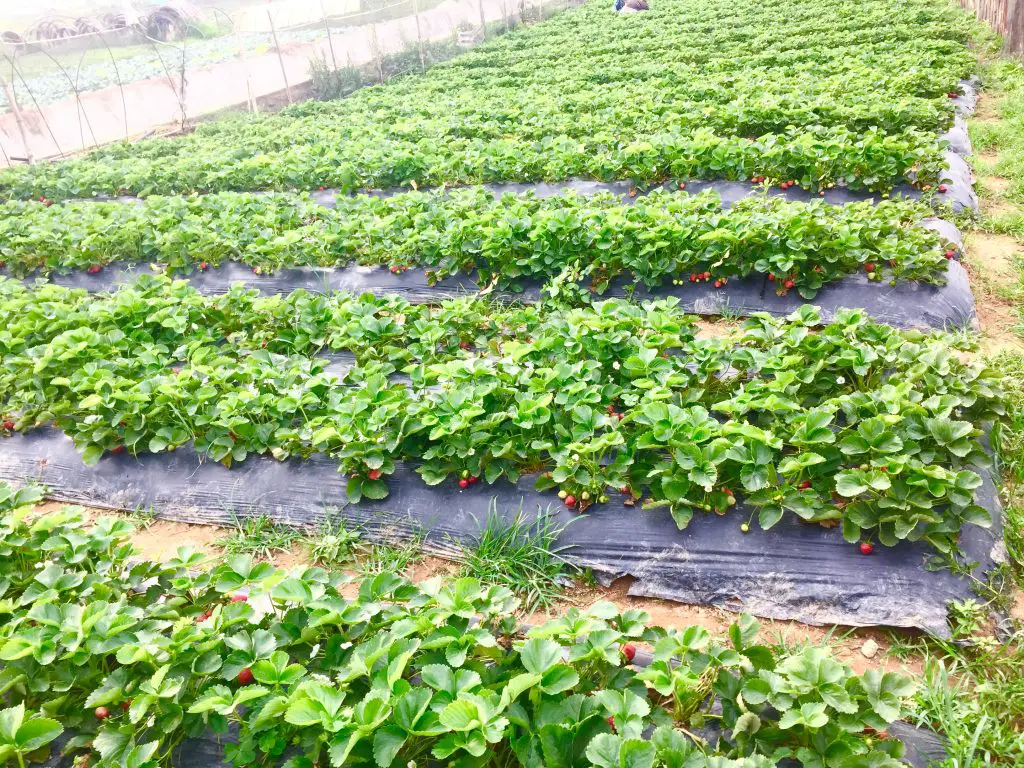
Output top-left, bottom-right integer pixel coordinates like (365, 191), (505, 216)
(0, 501), (913, 768)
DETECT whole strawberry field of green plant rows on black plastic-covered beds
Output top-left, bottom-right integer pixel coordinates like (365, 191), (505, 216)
(0, 0), (1008, 768)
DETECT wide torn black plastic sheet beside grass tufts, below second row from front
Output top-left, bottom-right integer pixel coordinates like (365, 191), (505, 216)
(0, 429), (1001, 636)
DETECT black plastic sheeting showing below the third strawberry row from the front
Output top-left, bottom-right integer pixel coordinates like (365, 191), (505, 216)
(44, 253), (977, 330)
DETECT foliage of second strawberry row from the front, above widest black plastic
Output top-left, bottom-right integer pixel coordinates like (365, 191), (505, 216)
(0, 278), (1002, 552)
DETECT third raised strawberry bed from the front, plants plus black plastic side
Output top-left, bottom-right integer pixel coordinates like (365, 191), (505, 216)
(0, 185), (974, 329)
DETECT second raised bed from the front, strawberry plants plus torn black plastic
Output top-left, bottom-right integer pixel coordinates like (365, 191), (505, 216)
(0, 280), (1001, 632)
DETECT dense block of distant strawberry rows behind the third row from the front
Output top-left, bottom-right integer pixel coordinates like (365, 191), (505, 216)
(0, 0), (972, 198)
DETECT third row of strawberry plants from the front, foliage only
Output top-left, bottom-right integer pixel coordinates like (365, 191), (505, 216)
(0, 188), (954, 298)
